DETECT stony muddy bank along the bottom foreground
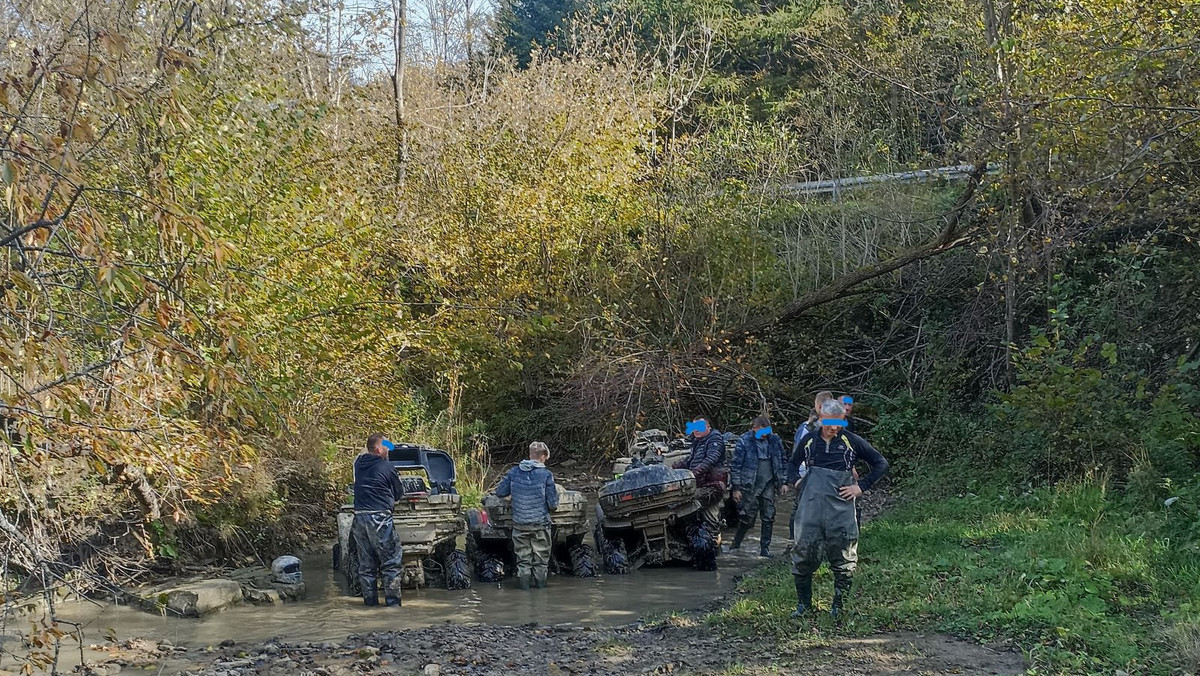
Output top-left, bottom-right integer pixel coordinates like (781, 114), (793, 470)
(83, 609), (1025, 676)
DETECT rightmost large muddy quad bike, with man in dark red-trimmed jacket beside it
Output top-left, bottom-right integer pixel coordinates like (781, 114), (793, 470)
(595, 430), (720, 574)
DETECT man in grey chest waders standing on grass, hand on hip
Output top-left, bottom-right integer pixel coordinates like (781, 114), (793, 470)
(792, 401), (888, 617)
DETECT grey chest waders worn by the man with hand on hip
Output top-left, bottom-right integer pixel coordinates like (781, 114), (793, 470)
(792, 467), (858, 617)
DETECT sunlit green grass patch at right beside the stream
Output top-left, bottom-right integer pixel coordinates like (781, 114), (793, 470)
(709, 477), (1200, 675)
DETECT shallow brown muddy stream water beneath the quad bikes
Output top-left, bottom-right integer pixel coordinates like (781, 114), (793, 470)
(44, 518), (787, 647)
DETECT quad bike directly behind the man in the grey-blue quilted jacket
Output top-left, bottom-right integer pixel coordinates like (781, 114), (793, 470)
(467, 486), (595, 582)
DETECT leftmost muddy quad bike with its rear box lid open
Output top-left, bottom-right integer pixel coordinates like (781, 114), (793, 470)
(334, 444), (470, 596)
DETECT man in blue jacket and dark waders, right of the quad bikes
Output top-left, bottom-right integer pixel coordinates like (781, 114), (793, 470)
(730, 415), (787, 557)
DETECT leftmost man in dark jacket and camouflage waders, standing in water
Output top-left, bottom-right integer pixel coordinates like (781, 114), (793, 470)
(350, 435), (404, 605)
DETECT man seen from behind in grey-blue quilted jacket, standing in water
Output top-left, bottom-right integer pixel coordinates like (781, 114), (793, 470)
(496, 442), (558, 590)
